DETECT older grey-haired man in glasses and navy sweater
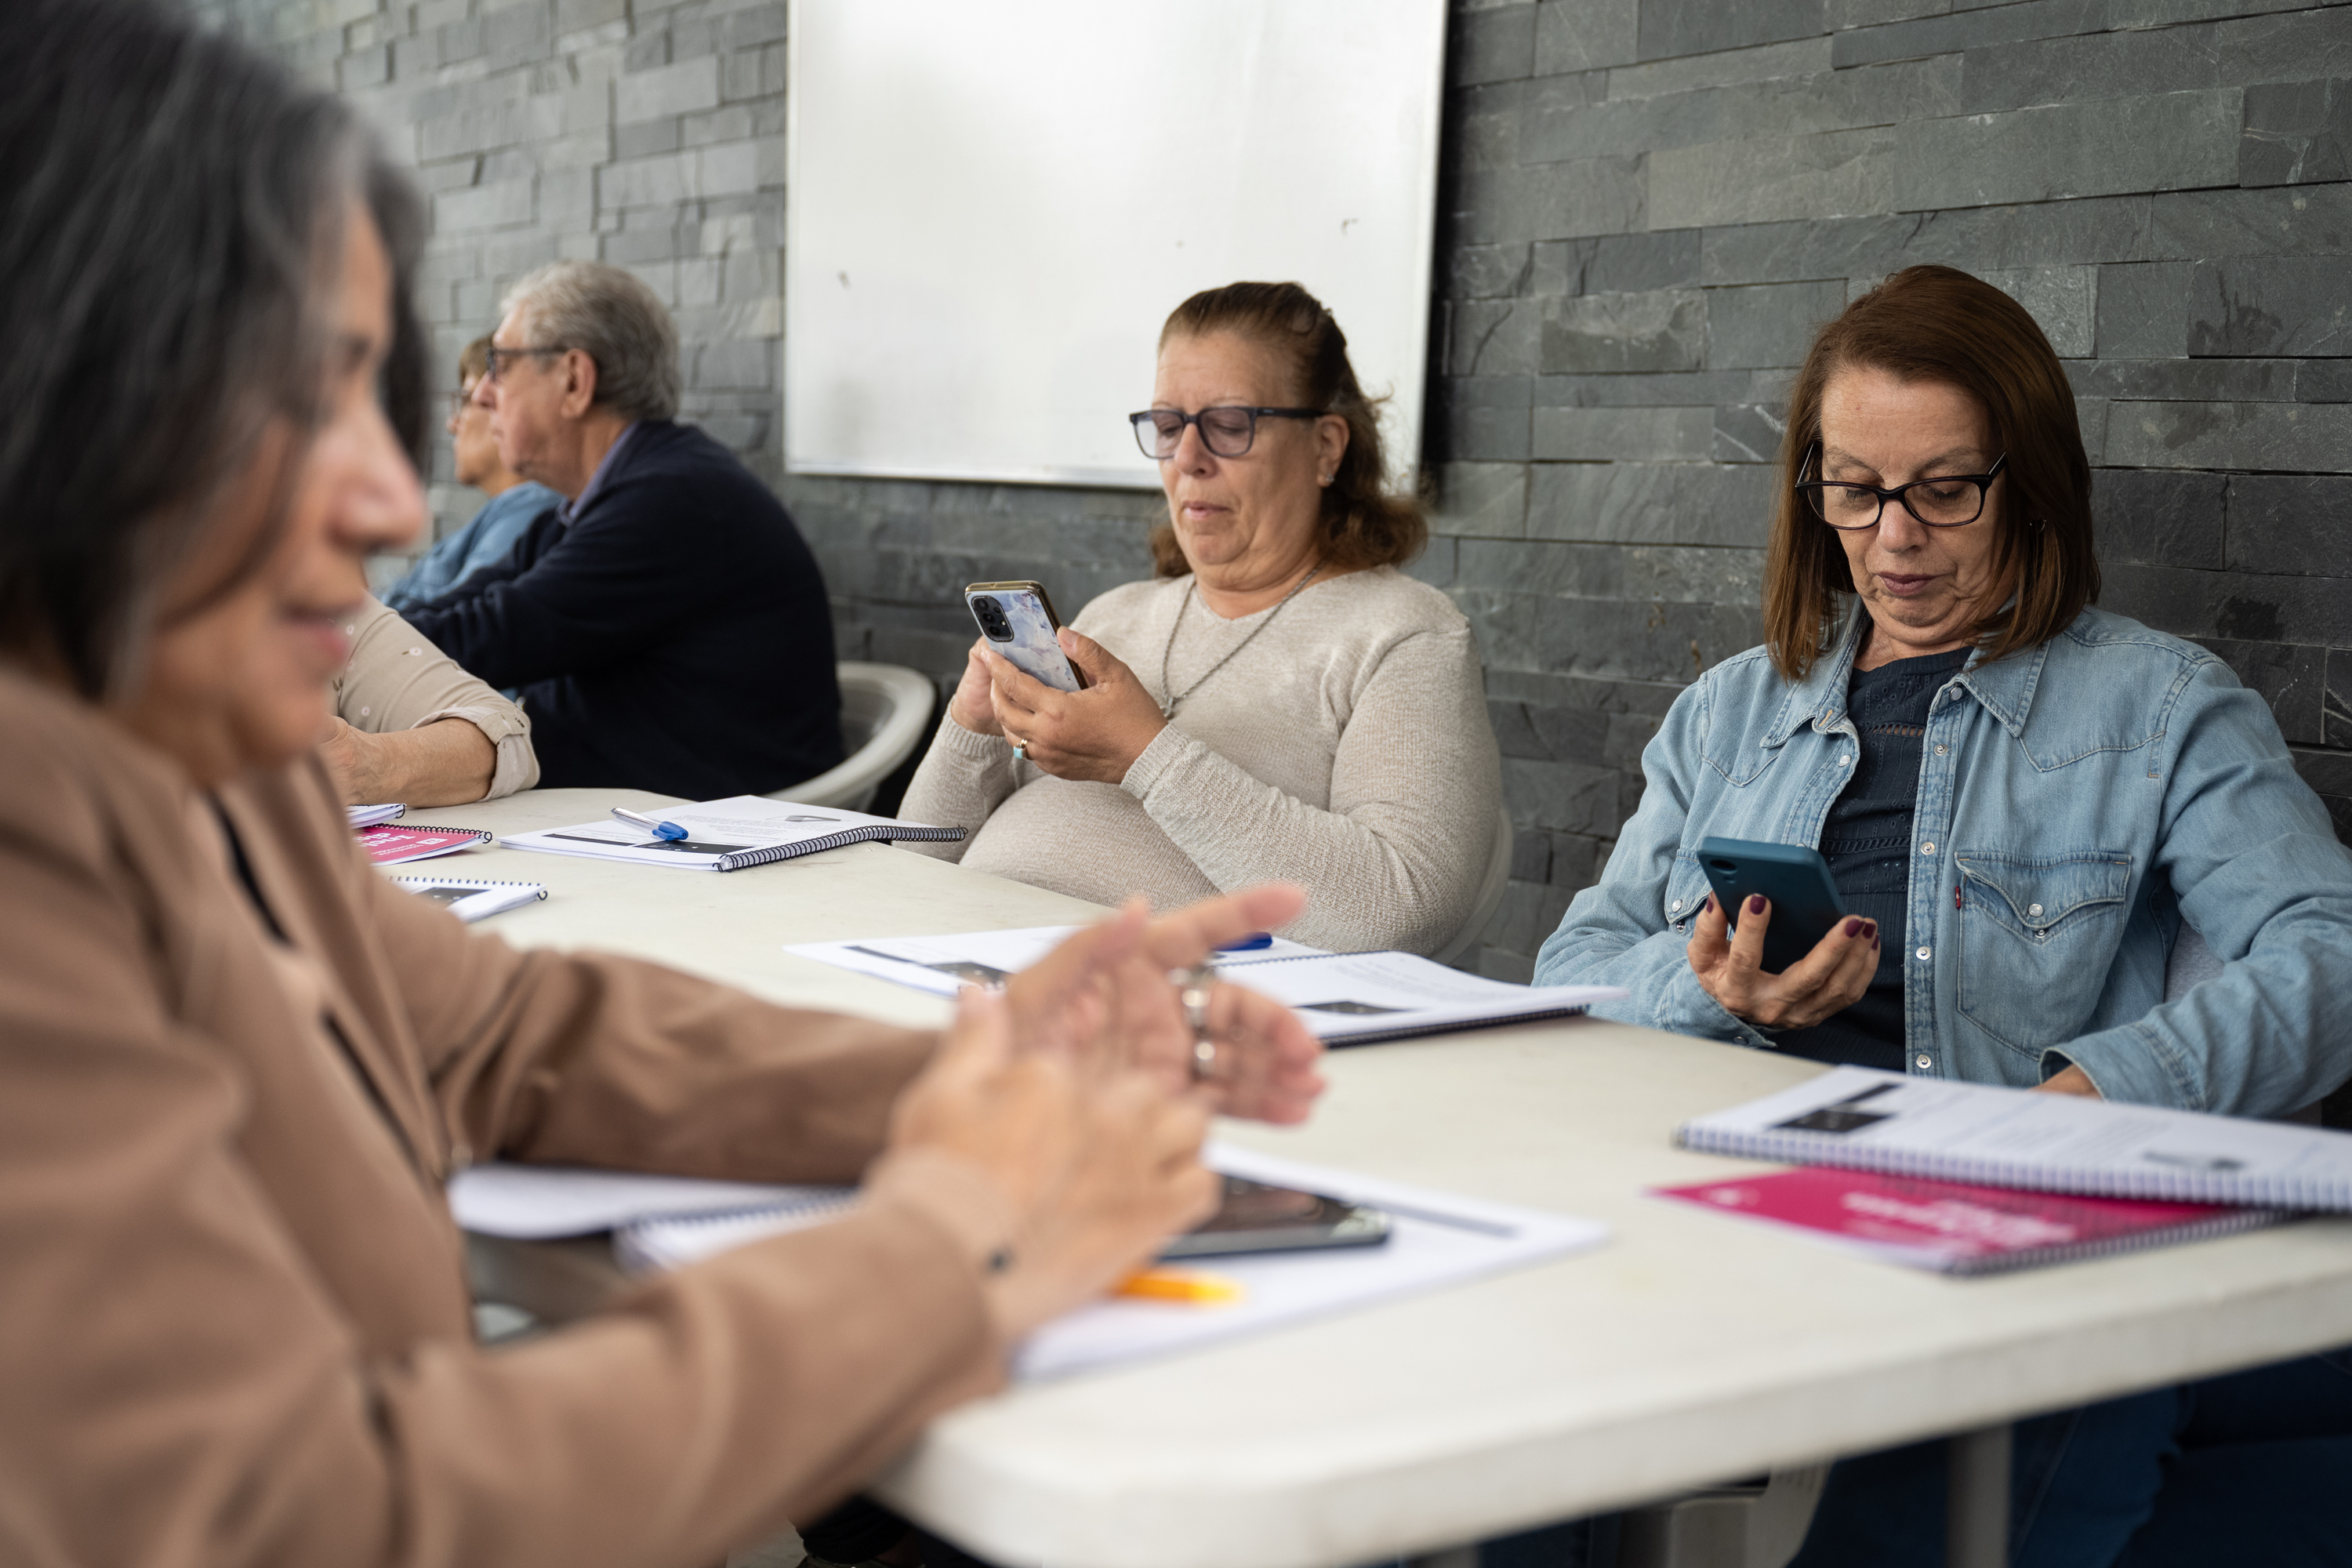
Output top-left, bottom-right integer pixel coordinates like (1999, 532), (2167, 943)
(407, 261), (842, 799)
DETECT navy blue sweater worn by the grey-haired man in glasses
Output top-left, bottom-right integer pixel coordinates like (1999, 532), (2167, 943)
(407, 421), (842, 799)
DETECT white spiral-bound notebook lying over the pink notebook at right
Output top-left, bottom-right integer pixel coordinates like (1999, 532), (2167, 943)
(1675, 1067), (2352, 1213)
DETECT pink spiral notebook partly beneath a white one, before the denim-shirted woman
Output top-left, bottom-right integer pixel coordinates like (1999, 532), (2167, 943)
(1651, 1166), (2286, 1274)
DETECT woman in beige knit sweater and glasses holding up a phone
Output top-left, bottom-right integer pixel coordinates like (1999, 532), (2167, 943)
(903, 282), (1501, 952)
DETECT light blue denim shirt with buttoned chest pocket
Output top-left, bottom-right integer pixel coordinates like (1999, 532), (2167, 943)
(1536, 609), (2352, 1114)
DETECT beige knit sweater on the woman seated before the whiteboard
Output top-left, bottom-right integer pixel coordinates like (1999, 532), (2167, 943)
(901, 567), (1503, 952)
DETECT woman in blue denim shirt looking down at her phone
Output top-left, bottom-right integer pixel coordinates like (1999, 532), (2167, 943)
(1536, 266), (2352, 1568)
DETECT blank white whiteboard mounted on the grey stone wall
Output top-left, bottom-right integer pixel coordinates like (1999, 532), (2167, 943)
(783, 0), (1446, 487)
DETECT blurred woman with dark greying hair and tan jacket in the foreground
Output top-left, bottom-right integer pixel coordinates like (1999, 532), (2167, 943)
(0, 0), (1319, 1568)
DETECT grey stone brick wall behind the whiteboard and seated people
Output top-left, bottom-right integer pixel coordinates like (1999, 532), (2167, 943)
(191, 0), (2352, 978)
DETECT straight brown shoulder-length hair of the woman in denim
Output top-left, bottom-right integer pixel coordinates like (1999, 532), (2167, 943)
(1764, 266), (2098, 682)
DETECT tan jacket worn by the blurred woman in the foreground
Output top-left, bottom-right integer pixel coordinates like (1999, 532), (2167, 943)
(0, 670), (1002, 1568)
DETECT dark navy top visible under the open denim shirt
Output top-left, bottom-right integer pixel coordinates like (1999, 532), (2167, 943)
(1778, 649), (1973, 1072)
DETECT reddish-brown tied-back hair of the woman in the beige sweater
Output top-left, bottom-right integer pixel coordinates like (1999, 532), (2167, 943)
(1152, 282), (1430, 579)
